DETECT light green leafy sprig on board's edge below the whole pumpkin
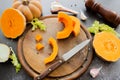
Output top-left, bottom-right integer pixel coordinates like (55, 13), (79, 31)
(31, 18), (46, 31)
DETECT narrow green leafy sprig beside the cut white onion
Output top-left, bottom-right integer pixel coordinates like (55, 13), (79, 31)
(9, 47), (21, 72)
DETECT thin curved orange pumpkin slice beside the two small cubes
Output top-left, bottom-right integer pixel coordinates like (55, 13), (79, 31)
(44, 37), (58, 64)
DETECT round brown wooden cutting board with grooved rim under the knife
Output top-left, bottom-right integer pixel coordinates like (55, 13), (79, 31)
(18, 16), (92, 80)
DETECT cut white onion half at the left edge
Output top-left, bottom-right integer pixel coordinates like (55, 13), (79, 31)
(0, 43), (10, 62)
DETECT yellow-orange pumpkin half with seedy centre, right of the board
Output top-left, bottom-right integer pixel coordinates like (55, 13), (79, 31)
(93, 32), (120, 62)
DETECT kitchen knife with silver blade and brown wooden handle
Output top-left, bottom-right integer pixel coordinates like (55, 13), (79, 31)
(34, 39), (90, 80)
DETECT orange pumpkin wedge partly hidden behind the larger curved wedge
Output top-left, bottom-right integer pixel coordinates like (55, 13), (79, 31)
(70, 16), (80, 36)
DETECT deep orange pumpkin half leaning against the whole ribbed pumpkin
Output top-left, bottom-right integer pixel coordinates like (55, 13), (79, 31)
(1, 8), (26, 38)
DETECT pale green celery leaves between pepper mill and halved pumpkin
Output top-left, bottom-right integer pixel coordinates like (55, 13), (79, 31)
(88, 21), (120, 37)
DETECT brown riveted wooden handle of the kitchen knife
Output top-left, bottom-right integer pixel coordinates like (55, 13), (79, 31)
(34, 59), (64, 80)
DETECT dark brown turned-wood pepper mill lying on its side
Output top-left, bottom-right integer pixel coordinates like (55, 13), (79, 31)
(85, 0), (120, 28)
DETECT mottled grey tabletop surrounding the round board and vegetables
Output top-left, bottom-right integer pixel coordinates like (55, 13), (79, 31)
(0, 0), (120, 80)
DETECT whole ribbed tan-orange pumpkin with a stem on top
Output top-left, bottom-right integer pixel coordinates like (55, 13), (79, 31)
(12, 0), (42, 21)
